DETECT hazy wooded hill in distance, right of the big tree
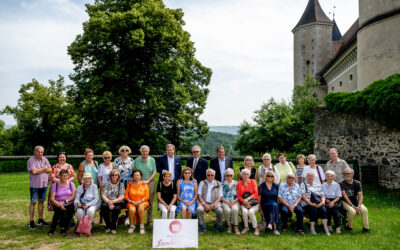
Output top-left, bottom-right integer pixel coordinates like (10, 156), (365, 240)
(196, 131), (238, 155)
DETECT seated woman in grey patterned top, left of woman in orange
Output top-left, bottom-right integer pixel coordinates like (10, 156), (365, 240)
(100, 169), (125, 234)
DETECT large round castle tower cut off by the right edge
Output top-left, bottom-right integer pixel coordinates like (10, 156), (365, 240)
(357, 0), (400, 90)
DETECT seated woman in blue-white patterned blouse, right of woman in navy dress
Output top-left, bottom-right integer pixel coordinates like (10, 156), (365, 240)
(278, 173), (304, 235)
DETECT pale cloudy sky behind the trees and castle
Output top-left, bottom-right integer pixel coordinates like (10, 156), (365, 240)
(0, 0), (358, 126)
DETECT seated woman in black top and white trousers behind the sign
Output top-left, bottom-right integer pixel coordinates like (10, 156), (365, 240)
(157, 171), (177, 219)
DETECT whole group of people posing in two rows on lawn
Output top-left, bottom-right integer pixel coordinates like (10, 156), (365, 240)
(27, 144), (369, 235)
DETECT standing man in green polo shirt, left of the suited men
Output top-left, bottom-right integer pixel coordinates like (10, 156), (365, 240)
(134, 145), (157, 226)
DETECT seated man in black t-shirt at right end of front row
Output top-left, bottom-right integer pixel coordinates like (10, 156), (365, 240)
(339, 168), (370, 233)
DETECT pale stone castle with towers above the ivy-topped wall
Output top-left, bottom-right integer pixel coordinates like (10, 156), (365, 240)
(292, 0), (400, 97)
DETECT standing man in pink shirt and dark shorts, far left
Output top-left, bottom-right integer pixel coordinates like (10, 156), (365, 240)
(27, 146), (51, 229)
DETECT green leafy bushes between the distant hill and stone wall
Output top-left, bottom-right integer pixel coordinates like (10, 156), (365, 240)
(235, 77), (319, 154)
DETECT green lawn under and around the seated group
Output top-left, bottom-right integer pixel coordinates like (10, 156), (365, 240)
(0, 173), (400, 249)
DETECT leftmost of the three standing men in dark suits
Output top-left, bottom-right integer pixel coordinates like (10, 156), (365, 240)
(157, 144), (182, 183)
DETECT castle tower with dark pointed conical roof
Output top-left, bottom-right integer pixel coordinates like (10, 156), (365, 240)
(292, 0), (341, 86)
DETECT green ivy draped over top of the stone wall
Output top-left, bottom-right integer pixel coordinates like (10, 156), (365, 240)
(324, 74), (400, 129)
